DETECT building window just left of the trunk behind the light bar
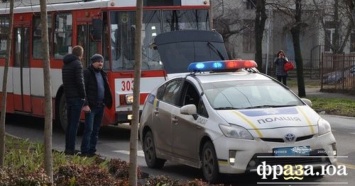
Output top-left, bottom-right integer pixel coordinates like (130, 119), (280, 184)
(243, 19), (255, 53)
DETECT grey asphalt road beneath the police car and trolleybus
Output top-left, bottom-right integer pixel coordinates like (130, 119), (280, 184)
(6, 115), (355, 186)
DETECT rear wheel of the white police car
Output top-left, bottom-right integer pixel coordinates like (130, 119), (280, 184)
(143, 131), (166, 169)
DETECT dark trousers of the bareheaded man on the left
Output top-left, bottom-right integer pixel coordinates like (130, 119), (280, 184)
(65, 98), (84, 154)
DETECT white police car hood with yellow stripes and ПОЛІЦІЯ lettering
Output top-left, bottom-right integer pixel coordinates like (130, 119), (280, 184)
(217, 106), (320, 134)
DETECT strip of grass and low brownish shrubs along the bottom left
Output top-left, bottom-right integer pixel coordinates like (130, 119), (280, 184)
(0, 136), (220, 186)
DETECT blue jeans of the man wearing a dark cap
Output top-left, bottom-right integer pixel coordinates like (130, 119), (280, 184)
(81, 105), (104, 155)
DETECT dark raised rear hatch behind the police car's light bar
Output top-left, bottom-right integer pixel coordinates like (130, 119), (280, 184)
(155, 30), (228, 74)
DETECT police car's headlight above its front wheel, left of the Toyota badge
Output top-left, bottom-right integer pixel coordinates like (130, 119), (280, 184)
(219, 124), (254, 140)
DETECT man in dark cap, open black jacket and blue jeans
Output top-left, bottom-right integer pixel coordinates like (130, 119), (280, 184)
(81, 54), (112, 156)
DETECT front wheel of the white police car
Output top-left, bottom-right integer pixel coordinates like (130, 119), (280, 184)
(201, 141), (219, 183)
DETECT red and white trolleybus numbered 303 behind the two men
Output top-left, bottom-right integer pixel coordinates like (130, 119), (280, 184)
(0, 0), (210, 131)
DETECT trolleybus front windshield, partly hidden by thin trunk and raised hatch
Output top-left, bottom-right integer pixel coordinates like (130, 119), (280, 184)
(110, 10), (209, 71)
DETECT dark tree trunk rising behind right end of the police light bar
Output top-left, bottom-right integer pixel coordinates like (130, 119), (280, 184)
(254, 0), (267, 72)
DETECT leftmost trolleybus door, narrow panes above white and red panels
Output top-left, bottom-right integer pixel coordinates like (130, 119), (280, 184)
(12, 26), (31, 112)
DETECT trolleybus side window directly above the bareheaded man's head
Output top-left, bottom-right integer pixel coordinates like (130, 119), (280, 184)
(53, 13), (73, 59)
